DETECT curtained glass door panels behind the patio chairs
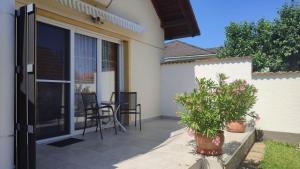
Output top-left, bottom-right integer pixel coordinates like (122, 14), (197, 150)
(74, 36), (119, 130)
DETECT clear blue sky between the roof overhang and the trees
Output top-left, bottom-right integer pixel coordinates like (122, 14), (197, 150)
(179, 0), (290, 48)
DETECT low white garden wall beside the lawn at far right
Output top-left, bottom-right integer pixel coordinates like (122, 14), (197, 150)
(253, 73), (300, 133)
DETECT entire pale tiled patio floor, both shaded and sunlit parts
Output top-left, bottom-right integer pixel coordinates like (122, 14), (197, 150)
(37, 119), (254, 169)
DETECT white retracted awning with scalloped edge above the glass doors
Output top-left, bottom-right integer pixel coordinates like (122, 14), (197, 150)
(57, 0), (144, 33)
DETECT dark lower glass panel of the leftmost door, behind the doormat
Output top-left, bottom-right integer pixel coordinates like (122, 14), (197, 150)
(37, 82), (70, 139)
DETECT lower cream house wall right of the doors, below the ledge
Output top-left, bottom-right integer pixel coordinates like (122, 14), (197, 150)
(129, 41), (162, 119)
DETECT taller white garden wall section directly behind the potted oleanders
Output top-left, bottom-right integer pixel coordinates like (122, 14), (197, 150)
(161, 58), (252, 116)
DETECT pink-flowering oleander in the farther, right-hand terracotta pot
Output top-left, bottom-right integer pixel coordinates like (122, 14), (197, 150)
(226, 80), (259, 133)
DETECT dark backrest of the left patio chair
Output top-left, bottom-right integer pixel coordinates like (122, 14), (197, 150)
(81, 93), (99, 113)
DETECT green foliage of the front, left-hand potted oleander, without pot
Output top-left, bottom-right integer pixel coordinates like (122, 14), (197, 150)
(176, 74), (225, 138)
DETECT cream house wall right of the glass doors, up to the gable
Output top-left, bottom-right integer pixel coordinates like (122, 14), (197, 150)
(108, 0), (164, 120)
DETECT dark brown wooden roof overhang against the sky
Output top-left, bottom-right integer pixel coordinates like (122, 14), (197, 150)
(151, 0), (200, 40)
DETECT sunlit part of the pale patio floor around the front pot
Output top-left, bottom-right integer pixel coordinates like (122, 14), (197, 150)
(116, 128), (255, 169)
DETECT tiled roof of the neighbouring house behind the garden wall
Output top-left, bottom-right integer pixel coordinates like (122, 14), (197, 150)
(161, 40), (218, 64)
